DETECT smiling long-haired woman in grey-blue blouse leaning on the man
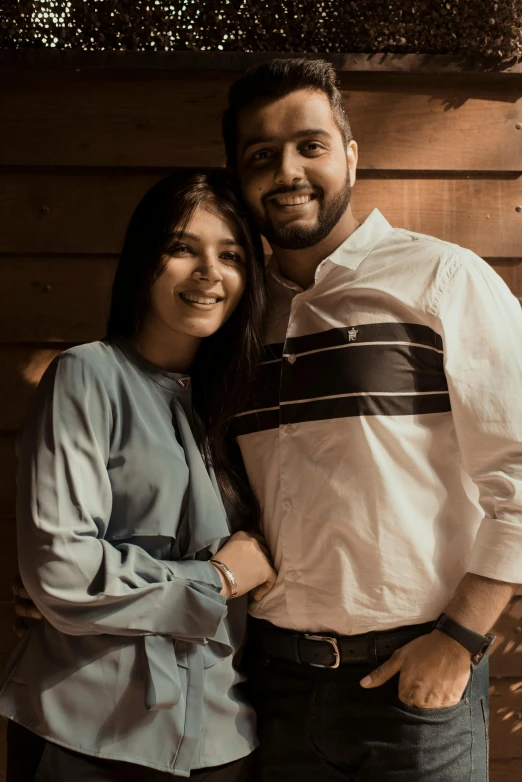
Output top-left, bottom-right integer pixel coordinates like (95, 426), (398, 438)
(0, 173), (275, 782)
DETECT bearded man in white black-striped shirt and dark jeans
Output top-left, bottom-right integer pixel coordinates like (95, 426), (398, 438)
(223, 59), (522, 782)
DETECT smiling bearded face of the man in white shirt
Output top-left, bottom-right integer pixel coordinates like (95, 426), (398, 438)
(237, 90), (357, 250)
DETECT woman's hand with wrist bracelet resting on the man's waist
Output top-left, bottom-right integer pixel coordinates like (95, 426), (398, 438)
(211, 532), (277, 600)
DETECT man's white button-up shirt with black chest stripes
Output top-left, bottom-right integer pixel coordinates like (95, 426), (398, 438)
(236, 210), (522, 635)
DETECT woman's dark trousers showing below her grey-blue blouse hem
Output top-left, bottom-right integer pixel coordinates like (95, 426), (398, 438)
(6, 722), (254, 782)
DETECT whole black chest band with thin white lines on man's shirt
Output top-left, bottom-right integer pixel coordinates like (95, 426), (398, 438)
(237, 323), (449, 434)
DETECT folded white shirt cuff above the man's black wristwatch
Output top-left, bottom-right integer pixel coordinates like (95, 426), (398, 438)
(468, 518), (522, 584)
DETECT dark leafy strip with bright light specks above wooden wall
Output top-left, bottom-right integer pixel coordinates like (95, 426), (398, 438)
(0, 0), (522, 59)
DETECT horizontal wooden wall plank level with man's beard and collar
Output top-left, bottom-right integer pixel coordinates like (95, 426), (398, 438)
(0, 169), (522, 258)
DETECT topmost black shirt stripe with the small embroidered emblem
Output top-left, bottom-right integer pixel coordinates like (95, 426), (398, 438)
(285, 323), (443, 353)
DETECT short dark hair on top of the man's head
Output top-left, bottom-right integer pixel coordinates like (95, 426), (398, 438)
(222, 57), (352, 167)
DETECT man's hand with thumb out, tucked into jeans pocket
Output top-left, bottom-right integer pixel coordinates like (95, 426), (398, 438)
(361, 630), (471, 709)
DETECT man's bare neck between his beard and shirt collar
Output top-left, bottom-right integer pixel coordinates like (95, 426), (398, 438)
(272, 206), (360, 290)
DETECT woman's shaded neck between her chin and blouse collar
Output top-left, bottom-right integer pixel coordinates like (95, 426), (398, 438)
(132, 323), (201, 373)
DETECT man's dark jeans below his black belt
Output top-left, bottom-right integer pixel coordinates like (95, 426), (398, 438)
(246, 624), (488, 782)
